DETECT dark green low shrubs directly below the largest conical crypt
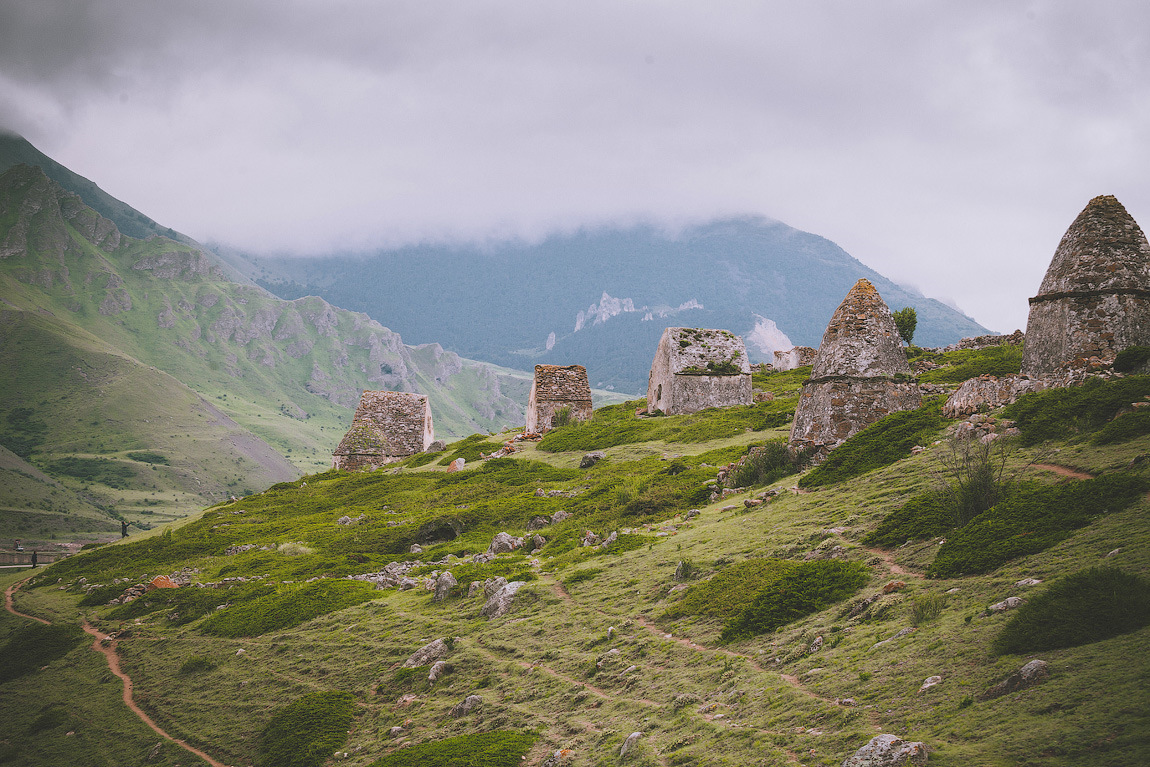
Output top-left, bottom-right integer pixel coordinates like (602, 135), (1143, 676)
(1003, 376), (1150, 445)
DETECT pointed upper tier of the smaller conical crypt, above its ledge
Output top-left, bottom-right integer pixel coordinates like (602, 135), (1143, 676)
(811, 279), (911, 381)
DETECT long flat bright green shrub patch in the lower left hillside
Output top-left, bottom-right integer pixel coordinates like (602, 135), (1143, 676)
(200, 581), (378, 637)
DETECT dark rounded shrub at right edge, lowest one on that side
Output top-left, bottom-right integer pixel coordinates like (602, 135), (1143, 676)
(992, 567), (1150, 655)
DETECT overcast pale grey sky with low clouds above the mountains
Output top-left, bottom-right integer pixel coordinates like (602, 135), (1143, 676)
(0, 0), (1150, 332)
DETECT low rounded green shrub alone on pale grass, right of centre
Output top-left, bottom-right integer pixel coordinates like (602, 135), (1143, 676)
(719, 560), (871, 642)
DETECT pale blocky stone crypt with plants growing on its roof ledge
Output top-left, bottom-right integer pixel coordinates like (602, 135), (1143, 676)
(647, 328), (751, 415)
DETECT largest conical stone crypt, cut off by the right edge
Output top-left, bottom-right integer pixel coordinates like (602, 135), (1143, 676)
(1022, 195), (1150, 377)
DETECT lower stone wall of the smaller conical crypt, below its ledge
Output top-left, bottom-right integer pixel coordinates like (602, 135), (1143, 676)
(789, 377), (922, 457)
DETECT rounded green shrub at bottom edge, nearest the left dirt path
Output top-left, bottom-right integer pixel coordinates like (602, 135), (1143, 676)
(259, 692), (354, 767)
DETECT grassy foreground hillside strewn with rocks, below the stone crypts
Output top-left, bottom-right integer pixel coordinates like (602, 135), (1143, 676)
(0, 374), (1150, 767)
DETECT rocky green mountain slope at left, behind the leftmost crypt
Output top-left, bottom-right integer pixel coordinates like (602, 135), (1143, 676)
(0, 160), (529, 533)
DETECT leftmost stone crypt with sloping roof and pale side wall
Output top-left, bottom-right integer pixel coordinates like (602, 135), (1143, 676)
(331, 391), (435, 471)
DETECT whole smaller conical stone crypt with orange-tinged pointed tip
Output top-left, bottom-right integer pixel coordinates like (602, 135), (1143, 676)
(789, 279), (922, 457)
